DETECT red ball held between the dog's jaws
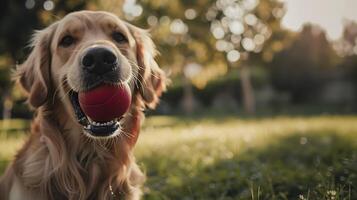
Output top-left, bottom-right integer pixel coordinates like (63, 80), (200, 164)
(78, 84), (131, 122)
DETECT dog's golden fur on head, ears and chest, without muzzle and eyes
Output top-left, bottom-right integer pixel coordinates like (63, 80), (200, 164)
(0, 11), (165, 200)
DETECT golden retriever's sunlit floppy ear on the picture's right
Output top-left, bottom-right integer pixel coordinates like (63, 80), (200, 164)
(128, 25), (167, 109)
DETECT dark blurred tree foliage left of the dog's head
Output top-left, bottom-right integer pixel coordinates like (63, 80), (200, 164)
(0, 0), (91, 117)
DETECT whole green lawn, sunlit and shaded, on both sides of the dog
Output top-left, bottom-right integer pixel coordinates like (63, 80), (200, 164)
(0, 116), (357, 200)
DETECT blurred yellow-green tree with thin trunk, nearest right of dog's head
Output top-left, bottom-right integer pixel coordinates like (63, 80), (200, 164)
(124, 0), (227, 112)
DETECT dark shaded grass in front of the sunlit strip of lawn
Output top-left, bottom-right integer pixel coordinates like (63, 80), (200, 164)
(141, 132), (357, 200)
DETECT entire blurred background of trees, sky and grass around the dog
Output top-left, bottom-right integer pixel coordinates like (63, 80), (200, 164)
(0, 0), (357, 199)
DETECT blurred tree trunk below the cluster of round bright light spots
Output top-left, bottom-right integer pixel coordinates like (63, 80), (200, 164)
(239, 65), (255, 115)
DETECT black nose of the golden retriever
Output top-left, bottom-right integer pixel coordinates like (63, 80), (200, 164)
(82, 47), (117, 74)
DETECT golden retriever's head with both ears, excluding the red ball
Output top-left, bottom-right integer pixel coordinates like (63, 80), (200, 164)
(17, 11), (165, 137)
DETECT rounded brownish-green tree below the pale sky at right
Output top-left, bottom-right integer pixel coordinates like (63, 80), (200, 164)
(271, 24), (337, 103)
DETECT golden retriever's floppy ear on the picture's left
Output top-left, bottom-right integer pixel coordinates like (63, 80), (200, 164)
(15, 25), (55, 108)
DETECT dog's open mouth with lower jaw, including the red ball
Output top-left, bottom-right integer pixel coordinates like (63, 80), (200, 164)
(69, 84), (131, 137)
